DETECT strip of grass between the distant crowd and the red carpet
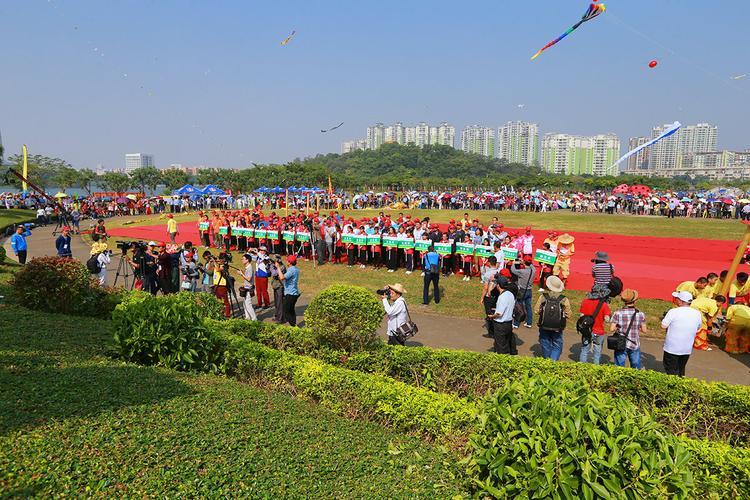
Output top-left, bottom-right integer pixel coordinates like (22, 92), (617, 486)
(106, 210), (745, 240)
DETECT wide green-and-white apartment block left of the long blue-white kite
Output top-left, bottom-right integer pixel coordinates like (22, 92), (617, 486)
(542, 134), (620, 176)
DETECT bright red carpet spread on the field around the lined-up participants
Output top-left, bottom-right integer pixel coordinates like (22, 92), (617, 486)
(108, 222), (744, 300)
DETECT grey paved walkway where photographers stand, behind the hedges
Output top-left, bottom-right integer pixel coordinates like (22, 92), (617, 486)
(4, 226), (750, 385)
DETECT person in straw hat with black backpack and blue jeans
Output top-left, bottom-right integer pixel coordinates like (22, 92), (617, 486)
(536, 276), (570, 361)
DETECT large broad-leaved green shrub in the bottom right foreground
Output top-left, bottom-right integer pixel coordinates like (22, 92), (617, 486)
(468, 376), (693, 499)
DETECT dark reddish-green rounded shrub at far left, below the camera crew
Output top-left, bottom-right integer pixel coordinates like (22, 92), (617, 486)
(11, 257), (122, 318)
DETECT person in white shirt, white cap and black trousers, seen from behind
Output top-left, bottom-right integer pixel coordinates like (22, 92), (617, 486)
(661, 292), (703, 377)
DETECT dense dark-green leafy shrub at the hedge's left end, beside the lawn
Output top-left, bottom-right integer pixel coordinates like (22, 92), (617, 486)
(112, 292), (223, 371)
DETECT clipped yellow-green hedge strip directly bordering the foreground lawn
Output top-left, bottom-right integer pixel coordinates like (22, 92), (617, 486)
(219, 334), (476, 438)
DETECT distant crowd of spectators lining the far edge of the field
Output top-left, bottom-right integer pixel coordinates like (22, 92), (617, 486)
(0, 185), (750, 219)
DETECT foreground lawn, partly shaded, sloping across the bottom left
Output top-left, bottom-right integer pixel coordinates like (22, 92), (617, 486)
(0, 306), (465, 498)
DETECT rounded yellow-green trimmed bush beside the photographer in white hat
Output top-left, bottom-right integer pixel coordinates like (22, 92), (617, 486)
(305, 285), (383, 352)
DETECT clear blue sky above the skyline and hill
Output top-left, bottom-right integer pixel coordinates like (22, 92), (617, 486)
(0, 0), (750, 168)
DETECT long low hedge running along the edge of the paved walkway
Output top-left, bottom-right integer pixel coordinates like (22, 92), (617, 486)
(209, 320), (750, 446)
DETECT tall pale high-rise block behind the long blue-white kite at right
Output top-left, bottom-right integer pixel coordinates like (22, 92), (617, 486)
(648, 123), (718, 175)
